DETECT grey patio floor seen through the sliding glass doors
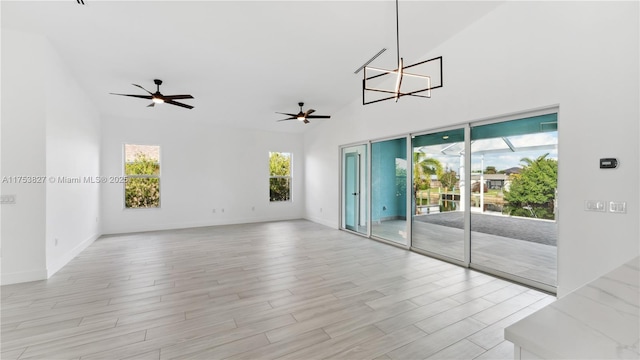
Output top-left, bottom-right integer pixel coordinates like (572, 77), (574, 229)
(373, 211), (558, 287)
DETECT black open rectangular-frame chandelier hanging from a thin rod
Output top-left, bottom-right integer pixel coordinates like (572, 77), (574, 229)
(356, 0), (443, 105)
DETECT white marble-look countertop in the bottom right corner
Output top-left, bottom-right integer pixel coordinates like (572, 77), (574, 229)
(505, 257), (640, 359)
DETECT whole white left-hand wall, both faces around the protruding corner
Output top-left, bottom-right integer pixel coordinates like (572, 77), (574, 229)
(1, 30), (100, 284)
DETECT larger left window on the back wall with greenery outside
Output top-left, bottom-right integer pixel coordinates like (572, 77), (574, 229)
(124, 144), (160, 209)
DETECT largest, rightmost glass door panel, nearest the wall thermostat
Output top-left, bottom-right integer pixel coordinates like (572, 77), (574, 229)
(470, 114), (558, 287)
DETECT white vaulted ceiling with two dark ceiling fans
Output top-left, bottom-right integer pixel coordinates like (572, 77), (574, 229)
(1, 0), (502, 132)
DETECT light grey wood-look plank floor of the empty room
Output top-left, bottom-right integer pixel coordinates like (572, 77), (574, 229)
(1, 220), (555, 360)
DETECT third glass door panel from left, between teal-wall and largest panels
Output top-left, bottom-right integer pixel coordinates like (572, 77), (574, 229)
(411, 129), (465, 261)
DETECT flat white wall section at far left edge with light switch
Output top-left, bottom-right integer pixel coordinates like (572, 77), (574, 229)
(1, 30), (46, 284)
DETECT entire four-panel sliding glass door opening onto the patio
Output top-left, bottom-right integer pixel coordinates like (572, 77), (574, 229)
(341, 108), (558, 292)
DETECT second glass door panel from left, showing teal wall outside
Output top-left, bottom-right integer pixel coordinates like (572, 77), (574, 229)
(371, 138), (407, 245)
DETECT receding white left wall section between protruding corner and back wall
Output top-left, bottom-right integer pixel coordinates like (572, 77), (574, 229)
(44, 39), (100, 276)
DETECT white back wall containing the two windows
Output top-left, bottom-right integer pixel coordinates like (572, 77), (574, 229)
(102, 114), (304, 234)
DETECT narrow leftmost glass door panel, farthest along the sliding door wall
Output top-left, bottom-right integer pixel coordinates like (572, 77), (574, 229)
(342, 145), (367, 234)
